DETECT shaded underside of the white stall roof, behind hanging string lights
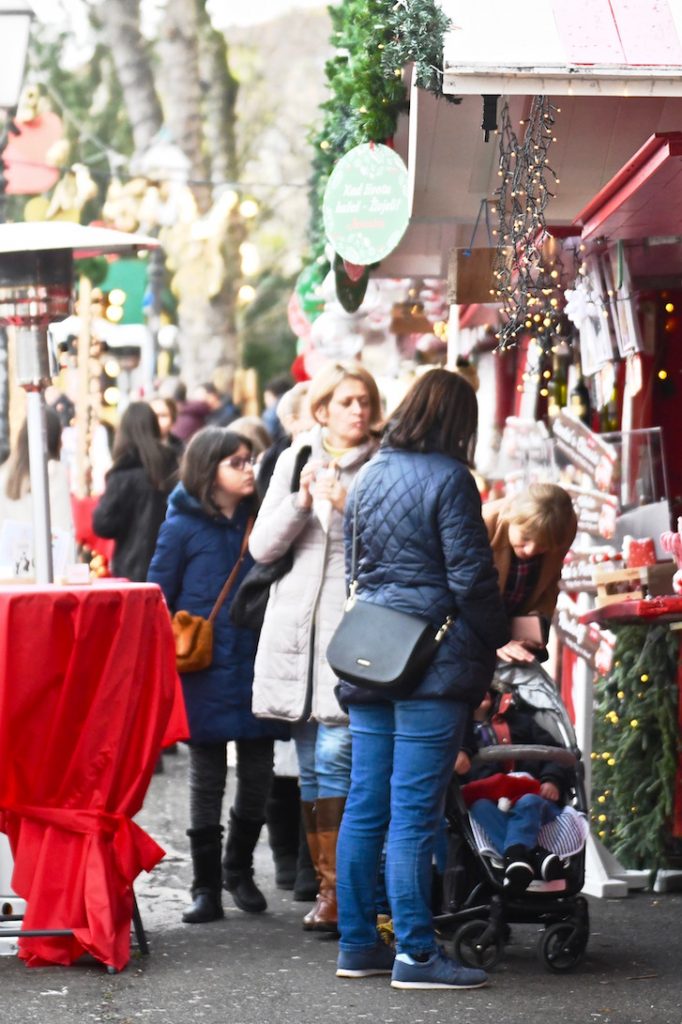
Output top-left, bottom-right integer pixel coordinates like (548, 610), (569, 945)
(379, 79), (682, 278)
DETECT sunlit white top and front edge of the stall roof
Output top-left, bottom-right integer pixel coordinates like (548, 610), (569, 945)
(440, 0), (682, 96)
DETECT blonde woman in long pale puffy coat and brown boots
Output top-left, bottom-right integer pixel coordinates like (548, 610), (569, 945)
(249, 362), (381, 931)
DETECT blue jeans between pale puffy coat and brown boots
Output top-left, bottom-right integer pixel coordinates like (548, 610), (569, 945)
(291, 722), (350, 803)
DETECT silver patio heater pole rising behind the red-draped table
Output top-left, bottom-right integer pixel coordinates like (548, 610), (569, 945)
(26, 389), (54, 584)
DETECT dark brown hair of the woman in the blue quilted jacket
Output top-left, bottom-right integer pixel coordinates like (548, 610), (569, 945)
(384, 370), (478, 466)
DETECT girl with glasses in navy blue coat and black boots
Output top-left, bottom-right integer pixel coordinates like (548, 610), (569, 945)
(147, 427), (286, 924)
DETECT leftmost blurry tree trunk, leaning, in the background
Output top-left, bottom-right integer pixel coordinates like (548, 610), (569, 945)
(96, 0), (163, 155)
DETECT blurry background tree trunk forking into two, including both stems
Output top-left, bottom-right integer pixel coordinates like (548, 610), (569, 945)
(90, 0), (238, 387)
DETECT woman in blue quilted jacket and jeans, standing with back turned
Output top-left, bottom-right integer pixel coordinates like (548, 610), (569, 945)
(337, 370), (509, 988)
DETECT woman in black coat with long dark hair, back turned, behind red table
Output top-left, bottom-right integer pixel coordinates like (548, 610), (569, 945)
(92, 401), (177, 583)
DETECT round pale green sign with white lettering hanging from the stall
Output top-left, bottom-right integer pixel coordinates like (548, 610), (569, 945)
(323, 142), (410, 266)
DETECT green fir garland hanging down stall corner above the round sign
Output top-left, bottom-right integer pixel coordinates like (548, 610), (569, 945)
(310, 0), (450, 262)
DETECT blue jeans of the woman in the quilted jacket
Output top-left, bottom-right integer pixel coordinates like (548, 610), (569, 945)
(336, 700), (469, 954)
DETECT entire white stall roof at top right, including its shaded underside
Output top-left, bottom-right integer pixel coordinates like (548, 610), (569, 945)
(380, 0), (682, 276)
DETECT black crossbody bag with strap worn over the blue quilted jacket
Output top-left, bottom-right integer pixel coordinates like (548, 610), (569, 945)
(327, 471), (453, 697)
